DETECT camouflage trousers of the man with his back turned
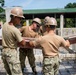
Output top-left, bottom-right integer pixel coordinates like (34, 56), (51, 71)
(43, 56), (59, 75)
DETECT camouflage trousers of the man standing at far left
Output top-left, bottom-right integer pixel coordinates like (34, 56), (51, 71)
(2, 48), (22, 75)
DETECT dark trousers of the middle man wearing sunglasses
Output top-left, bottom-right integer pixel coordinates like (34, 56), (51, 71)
(19, 48), (35, 71)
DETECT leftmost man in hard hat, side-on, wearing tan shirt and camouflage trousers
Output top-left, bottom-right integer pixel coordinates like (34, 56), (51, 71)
(2, 7), (25, 75)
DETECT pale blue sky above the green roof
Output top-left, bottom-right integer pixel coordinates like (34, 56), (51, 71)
(5, 0), (76, 10)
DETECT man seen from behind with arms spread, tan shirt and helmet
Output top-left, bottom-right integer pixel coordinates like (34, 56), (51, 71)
(30, 17), (70, 75)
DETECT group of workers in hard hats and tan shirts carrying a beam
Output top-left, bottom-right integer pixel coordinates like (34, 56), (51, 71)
(2, 7), (70, 75)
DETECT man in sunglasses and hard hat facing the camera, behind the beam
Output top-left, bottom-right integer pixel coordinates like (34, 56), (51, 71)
(19, 18), (41, 75)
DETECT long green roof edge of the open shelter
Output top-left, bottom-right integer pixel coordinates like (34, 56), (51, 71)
(23, 8), (76, 14)
